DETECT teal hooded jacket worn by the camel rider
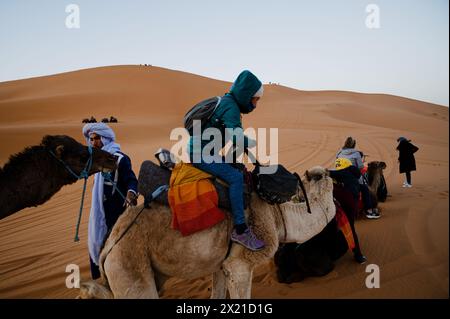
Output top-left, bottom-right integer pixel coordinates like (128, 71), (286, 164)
(188, 70), (262, 159)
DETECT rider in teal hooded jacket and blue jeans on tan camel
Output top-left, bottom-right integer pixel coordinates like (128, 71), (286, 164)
(188, 70), (265, 251)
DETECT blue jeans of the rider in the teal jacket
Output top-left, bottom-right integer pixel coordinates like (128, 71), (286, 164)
(193, 162), (245, 225)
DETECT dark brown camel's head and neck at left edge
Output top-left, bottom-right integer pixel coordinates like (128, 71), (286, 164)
(0, 135), (116, 219)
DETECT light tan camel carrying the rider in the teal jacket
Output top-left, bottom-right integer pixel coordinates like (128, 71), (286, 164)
(79, 167), (336, 298)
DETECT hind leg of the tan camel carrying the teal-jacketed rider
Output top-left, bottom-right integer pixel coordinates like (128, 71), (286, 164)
(105, 246), (159, 299)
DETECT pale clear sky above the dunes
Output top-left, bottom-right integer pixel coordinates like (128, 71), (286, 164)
(0, 0), (449, 106)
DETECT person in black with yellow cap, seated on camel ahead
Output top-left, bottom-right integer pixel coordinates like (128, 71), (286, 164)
(329, 158), (367, 264)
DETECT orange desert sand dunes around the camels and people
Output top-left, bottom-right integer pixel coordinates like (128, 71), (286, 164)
(0, 66), (449, 298)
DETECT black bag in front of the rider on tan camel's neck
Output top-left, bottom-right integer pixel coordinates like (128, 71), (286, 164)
(252, 165), (299, 205)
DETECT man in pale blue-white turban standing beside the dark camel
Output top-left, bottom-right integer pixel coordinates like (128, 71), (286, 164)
(83, 123), (137, 279)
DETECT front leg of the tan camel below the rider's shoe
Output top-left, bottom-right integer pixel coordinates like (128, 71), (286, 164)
(224, 258), (253, 299)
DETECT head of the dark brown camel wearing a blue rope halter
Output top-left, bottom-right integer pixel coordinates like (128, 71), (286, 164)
(41, 135), (117, 175)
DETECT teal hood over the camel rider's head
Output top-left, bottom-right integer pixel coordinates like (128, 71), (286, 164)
(230, 70), (262, 114)
